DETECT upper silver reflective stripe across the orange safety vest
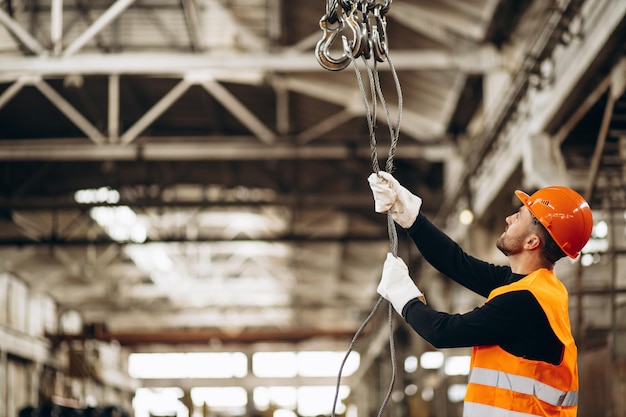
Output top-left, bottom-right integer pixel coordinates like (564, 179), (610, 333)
(469, 368), (578, 407)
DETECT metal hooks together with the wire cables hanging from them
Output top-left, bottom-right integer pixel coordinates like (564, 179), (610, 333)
(316, 0), (403, 417)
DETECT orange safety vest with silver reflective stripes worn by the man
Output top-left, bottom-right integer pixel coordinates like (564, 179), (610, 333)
(463, 269), (578, 417)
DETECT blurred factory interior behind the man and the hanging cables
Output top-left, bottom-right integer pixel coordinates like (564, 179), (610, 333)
(0, 0), (626, 417)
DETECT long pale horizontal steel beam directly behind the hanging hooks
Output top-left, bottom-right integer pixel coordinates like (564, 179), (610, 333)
(0, 46), (502, 82)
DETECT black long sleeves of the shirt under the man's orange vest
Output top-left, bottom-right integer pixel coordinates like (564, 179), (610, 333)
(402, 214), (563, 364)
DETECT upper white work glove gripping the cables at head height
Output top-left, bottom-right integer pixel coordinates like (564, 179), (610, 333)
(367, 171), (422, 229)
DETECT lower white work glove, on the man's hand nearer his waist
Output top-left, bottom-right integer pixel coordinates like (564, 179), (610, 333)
(376, 253), (426, 315)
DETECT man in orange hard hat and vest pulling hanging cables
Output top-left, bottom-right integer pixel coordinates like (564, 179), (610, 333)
(368, 172), (593, 417)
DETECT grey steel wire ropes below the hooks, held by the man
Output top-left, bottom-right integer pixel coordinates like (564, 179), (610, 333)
(331, 17), (403, 417)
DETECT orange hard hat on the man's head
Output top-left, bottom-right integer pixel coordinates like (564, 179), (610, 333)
(515, 186), (593, 259)
